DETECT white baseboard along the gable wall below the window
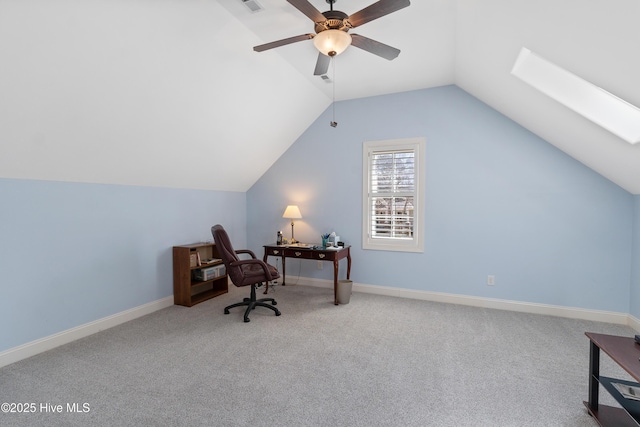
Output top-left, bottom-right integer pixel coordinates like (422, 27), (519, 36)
(292, 276), (640, 331)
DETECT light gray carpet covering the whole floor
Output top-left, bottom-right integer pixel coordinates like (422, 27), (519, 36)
(0, 286), (634, 427)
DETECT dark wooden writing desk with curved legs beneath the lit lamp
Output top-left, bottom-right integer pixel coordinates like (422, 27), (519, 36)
(263, 245), (351, 305)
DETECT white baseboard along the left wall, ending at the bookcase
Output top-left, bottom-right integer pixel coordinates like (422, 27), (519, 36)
(0, 295), (173, 368)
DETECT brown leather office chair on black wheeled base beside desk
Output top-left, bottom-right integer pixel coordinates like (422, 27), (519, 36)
(211, 224), (280, 322)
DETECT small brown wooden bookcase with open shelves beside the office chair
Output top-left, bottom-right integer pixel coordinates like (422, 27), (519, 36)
(173, 243), (229, 307)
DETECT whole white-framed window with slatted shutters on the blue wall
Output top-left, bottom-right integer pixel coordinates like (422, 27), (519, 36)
(362, 138), (425, 252)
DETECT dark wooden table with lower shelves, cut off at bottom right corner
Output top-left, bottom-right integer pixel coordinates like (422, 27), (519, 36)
(583, 332), (640, 426)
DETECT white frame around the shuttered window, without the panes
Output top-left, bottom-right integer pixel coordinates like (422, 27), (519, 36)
(362, 138), (426, 252)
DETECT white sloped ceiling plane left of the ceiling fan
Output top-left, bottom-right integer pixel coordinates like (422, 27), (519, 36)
(0, 0), (331, 191)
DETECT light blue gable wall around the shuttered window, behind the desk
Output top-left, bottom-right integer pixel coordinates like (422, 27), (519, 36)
(247, 86), (638, 314)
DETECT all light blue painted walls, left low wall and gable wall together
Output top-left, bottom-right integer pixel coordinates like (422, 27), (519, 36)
(0, 86), (640, 351)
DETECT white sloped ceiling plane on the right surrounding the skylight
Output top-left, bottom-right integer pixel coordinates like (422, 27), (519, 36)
(455, 0), (640, 194)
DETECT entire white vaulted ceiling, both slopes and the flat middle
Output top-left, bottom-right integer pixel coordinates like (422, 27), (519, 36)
(0, 0), (640, 194)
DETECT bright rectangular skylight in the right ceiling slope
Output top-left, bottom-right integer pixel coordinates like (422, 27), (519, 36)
(511, 47), (640, 144)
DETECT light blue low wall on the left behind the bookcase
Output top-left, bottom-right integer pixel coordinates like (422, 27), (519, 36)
(0, 179), (246, 351)
